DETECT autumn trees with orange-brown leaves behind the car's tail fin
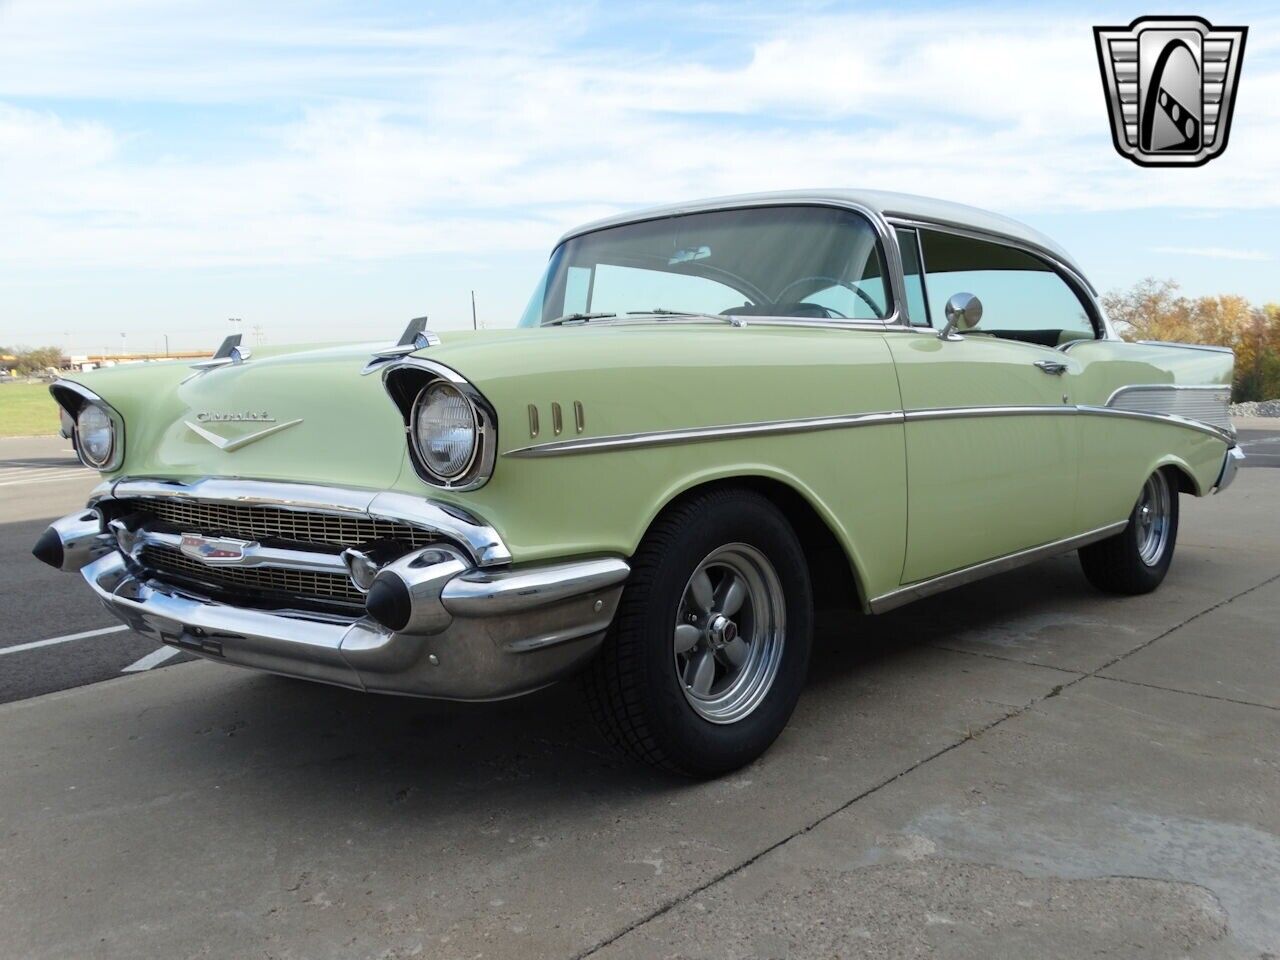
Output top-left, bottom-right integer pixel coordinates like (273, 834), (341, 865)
(1102, 278), (1280, 403)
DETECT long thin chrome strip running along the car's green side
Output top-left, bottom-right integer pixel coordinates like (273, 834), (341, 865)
(502, 403), (1235, 460)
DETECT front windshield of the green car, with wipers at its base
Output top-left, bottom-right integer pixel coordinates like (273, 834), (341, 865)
(520, 206), (891, 326)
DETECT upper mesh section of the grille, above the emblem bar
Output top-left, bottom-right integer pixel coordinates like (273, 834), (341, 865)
(118, 498), (438, 547)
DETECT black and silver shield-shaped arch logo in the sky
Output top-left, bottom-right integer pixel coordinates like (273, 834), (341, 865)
(1093, 17), (1249, 166)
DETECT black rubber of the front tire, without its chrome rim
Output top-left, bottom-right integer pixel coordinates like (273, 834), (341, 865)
(584, 488), (813, 777)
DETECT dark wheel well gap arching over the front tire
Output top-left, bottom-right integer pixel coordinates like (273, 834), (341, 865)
(659, 476), (865, 609)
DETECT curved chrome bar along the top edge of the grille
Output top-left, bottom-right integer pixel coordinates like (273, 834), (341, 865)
(90, 476), (511, 567)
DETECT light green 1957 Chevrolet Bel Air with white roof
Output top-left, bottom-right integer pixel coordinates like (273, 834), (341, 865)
(35, 191), (1242, 776)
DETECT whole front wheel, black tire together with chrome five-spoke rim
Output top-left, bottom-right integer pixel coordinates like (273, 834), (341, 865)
(585, 489), (813, 777)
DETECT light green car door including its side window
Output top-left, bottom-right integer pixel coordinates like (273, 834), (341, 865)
(888, 229), (1097, 584)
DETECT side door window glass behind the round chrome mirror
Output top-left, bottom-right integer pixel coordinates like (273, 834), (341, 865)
(920, 230), (1097, 347)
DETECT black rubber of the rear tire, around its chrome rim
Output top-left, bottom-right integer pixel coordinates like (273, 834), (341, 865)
(1080, 470), (1178, 595)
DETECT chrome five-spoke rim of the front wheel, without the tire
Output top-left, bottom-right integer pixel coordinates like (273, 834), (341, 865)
(673, 543), (786, 723)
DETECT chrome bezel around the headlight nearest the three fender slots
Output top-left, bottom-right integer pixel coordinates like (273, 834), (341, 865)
(383, 357), (498, 492)
